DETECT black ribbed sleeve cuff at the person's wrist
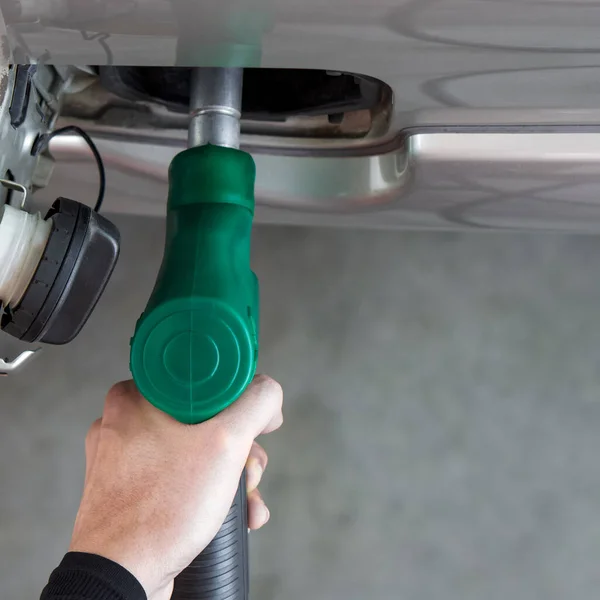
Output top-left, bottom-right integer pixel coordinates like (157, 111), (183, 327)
(40, 552), (147, 600)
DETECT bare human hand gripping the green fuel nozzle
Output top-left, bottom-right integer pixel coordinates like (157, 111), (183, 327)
(69, 376), (283, 600)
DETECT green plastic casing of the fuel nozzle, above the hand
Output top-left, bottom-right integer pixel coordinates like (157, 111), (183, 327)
(130, 145), (259, 424)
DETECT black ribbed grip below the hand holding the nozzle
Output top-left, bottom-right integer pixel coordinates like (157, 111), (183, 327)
(171, 472), (249, 600)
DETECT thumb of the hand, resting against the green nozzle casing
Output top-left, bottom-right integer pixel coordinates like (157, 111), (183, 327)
(215, 375), (283, 443)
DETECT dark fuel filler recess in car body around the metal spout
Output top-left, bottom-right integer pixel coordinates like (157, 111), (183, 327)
(63, 66), (393, 139)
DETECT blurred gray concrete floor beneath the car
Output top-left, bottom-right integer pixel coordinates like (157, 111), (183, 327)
(0, 218), (600, 600)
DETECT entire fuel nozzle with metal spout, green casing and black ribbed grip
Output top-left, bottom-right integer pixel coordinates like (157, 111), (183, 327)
(131, 69), (259, 600)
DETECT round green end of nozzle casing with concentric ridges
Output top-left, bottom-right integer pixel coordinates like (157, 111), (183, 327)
(131, 297), (256, 423)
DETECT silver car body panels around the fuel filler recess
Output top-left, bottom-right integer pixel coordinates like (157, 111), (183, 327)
(0, 0), (600, 232)
